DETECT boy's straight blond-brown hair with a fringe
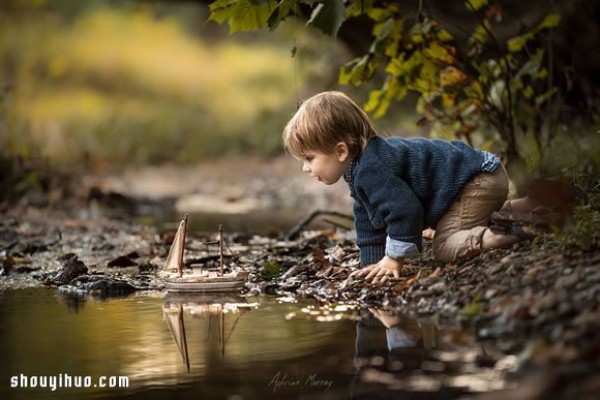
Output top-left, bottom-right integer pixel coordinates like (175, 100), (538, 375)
(283, 91), (376, 158)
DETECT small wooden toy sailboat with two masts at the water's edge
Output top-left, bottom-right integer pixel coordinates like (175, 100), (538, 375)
(163, 214), (249, 293)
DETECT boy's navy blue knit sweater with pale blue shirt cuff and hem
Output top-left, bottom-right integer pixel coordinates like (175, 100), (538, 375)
(344, 136), (500, 265)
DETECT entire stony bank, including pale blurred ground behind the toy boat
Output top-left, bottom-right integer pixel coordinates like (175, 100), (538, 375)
(0, 157), (600, 399)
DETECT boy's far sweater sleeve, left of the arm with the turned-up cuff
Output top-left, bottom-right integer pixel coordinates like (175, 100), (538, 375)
(354, 200), (386, 266)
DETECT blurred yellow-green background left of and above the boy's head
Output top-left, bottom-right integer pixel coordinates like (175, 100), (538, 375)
(0, 0), (376, 171)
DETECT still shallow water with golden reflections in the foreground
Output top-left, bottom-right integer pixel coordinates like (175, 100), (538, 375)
(0, 288), (506, 400)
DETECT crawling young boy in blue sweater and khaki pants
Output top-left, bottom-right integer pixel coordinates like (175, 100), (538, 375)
(283, 92), (532, 283)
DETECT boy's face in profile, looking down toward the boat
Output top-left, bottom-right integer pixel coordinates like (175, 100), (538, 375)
(300, 142), (351, 185)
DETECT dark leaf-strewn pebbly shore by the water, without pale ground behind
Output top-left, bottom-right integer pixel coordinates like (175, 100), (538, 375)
(0, 200), (600, 399)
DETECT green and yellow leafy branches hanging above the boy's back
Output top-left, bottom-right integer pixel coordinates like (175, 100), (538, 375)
(211, 0), (600, 179)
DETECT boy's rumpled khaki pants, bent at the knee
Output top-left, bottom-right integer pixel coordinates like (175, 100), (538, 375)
(433, 166), (508, 262)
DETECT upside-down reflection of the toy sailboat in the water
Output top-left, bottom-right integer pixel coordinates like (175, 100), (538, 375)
(163, 293), (258, 372)
